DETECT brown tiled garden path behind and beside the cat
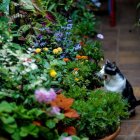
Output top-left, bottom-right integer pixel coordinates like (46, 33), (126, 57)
(100, 0), (140, 140)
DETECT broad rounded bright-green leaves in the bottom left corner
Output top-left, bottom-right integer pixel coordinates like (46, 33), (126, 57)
(0, 98), (64, 140)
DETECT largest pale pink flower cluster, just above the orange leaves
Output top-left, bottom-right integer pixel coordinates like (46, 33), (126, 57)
(35, 88), (56, 103)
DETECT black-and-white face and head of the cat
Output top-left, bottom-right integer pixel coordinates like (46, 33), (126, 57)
(97, 60), (117, 78)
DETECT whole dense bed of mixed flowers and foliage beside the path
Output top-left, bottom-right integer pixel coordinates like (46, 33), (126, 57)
(0, 0), (127, 140)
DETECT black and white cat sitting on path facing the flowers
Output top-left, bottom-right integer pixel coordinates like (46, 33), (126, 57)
(97, 60), (140, 116)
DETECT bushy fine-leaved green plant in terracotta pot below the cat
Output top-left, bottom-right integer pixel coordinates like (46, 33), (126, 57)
(62, 89), (128, 140)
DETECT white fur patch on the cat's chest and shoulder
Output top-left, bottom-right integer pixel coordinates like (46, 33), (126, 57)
(104, 74), (126, 93)
